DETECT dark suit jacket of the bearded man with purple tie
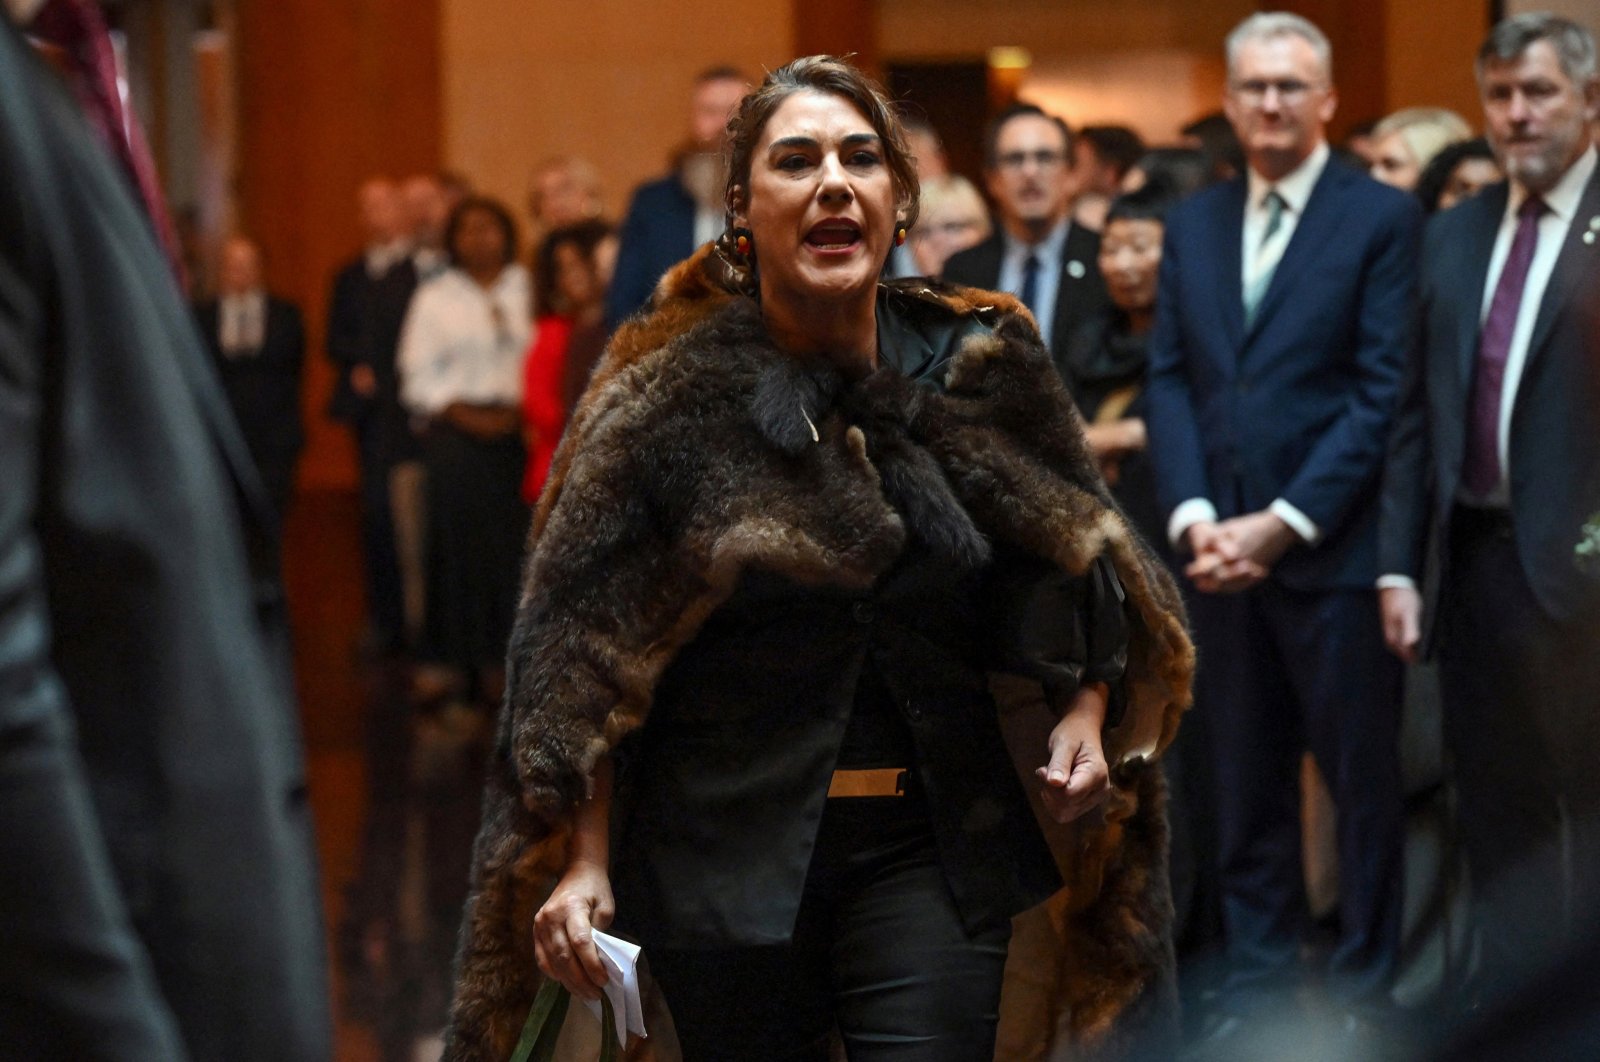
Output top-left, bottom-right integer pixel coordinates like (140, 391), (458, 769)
(1381, 174), (1600, 621)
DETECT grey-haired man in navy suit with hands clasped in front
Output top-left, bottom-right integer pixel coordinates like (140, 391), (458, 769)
(1149, 6), (1421, 1027)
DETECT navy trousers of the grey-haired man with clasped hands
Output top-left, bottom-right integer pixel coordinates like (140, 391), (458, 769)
(1194, 581), (1403, 1009)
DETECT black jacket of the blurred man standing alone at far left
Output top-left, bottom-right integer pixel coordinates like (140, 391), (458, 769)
(195, 296), (306, 465)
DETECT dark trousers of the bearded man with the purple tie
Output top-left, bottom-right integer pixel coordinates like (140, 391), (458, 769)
(1438, 507), (1600, 988)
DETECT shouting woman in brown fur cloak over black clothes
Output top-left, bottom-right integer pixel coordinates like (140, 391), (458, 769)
(445, 56), (1194, 1062)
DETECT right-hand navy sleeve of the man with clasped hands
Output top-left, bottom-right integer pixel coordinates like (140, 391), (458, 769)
(1282, 195), (1422, 531)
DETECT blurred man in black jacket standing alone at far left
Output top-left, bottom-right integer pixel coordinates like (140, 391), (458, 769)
(195, 237), (306, 523)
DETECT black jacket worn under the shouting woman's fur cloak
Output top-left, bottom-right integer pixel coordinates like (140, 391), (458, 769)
(613, 297), (1126, 948)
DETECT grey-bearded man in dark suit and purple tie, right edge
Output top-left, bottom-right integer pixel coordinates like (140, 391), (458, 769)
(1379, 14), (1600, 998)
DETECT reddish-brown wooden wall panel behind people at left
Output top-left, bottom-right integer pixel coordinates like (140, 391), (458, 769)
(235, 0), (442, 488)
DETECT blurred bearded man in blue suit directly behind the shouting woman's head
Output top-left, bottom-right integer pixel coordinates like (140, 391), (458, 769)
(605, 67), (749, 329)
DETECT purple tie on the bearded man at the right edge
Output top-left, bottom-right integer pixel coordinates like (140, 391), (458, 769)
(1461, 195), (1546, 497)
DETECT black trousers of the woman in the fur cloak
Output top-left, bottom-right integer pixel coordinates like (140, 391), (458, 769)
(650, 795), (1011, 1062)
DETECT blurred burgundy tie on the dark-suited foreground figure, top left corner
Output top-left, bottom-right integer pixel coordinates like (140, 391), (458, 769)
(27, 0), (184, 285)
